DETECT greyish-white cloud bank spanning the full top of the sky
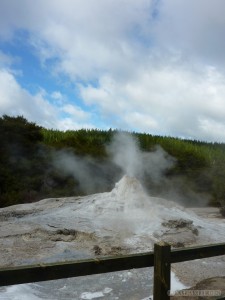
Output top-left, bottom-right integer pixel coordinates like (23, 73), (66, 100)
(0, 0), (225, 79)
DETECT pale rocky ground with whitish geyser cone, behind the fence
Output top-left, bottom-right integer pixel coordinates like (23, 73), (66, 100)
(0, 176), (225, 300)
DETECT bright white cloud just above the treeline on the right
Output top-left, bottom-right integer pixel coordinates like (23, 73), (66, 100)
(81, 66), (225, 141)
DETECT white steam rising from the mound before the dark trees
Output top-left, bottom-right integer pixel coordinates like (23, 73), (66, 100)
(54, 132), (175, 193)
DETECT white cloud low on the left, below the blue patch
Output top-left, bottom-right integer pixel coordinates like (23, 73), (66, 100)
(0, 69), (93, 130)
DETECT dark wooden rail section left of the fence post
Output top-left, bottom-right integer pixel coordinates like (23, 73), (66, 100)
(0, 252), (154, 286)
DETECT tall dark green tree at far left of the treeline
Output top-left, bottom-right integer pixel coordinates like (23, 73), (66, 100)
(0, 115), (43, 207)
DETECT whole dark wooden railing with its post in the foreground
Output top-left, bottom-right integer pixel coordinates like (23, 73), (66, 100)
(0, 242), (225, 300)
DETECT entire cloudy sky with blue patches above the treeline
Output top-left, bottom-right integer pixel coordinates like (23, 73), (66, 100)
(0, 0), (225, 142)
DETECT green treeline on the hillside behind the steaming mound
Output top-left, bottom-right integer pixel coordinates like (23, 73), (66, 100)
(0, 115), (225, 207)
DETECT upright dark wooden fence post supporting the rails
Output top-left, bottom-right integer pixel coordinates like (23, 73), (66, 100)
(153, 242), (171, 300)
